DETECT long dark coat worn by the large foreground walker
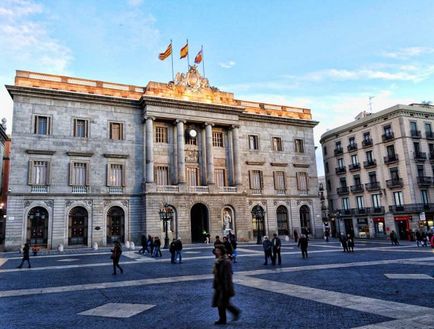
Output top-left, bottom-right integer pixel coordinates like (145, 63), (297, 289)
(212, 256), (235, 307)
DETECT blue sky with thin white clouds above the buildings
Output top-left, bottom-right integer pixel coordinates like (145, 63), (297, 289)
(0, 0), (434, 174)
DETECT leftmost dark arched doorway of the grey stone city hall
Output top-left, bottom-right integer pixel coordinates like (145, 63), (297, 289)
(27, 207), (48, 245)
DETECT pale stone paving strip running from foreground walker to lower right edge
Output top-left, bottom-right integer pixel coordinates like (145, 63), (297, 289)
(234, 276), (434, 319)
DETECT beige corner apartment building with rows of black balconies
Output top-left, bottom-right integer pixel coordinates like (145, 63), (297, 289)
(321, 104), (434, 240)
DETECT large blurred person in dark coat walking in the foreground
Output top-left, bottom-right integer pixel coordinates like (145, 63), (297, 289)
(212, 245), (241, 325)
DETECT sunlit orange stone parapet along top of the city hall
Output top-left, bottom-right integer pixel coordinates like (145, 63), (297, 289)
(15, 71), (312, 120)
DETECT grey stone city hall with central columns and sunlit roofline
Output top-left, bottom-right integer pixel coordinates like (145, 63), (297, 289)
(5, 67), (323, 249)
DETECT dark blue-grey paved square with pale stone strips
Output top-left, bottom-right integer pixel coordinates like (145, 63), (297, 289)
(0, 240), (434, 329)
